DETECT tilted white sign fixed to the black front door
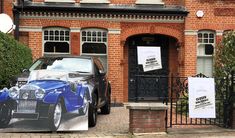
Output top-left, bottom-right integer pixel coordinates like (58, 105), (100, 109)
(137, 46), (162, 72)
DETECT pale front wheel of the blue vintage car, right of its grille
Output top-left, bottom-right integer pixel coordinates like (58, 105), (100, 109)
(48, 102), (62, 131)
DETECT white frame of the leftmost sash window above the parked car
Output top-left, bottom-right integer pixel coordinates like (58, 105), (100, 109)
(42, 27), (71, 55)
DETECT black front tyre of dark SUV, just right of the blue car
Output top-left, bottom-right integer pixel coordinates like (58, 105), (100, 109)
(88, 93), (97, 127)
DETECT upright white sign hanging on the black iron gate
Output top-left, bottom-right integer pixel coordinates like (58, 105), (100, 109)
(188, 77), (215, 118)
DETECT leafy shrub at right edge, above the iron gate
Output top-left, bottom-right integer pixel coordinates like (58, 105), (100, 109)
(215, 31), (235, 77)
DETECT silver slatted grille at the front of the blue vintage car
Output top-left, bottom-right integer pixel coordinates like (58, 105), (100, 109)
(17, 100), (37, 113)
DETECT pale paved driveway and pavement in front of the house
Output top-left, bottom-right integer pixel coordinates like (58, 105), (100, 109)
(0, 107), (235, 138)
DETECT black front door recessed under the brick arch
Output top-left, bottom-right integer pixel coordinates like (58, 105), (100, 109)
(128, 35), (169, 101)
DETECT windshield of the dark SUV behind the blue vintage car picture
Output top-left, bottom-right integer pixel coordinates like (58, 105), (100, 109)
(29, 58), (92, 73)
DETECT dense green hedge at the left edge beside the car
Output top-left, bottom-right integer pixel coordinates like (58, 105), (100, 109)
(0, 32), (32, 88)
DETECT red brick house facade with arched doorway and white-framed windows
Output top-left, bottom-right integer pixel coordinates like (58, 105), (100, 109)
(1, 0), (235, 103)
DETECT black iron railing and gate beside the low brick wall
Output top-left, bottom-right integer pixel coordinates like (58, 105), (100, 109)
(131, 73), (235, 128)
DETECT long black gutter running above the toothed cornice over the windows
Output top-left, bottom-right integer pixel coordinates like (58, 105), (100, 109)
(14, 3), (189, 16)
